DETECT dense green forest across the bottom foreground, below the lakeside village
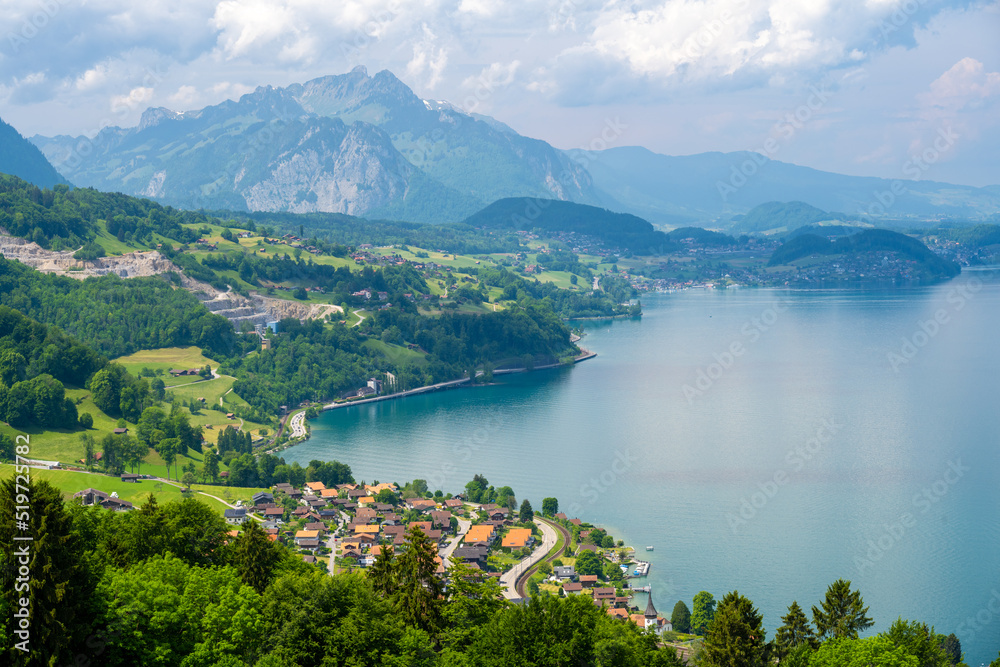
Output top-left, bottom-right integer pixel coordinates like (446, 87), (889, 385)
(0, 480), (1000, 667)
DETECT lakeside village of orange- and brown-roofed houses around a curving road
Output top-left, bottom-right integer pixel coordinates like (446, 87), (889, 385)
(73, 474), (673, 635)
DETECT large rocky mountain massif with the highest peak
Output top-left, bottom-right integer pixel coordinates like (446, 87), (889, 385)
(32, 68), (597, 222)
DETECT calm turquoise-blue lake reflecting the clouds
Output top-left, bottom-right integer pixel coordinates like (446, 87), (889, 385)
(285, 272), (1000, 666)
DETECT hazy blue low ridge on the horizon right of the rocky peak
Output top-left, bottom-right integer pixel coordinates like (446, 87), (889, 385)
(568, 146), (1000, 227)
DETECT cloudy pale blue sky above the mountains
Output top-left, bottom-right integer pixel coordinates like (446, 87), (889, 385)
(0, 0), (1000, 186)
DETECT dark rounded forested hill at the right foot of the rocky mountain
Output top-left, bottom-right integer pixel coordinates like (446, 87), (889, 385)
(464, 197), (678, 254)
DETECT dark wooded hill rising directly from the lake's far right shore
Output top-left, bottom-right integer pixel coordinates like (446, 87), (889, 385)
(768, 229), (961, 278)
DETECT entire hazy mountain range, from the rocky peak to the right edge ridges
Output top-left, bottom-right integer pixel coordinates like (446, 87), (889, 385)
(19, 67), (1000, 229)
